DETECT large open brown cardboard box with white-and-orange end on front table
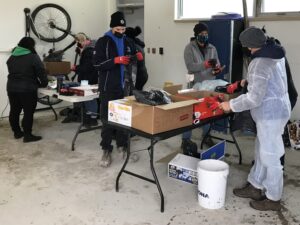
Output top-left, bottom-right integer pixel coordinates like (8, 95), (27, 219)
(108, 96), (197, 134)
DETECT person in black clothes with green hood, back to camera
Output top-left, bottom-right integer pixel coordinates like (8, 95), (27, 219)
(6, 37), (48, 143)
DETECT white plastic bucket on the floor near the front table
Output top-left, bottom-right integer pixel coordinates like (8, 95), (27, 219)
(197, 159), (229, 209)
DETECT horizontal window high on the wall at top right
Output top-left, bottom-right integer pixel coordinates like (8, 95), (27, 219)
(175, 0), (300, 20)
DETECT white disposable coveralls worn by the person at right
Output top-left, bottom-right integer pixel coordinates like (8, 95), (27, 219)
(229, 57), (291, 201)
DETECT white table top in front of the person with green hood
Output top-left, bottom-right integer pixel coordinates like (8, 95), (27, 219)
(38, 88), (99, 102)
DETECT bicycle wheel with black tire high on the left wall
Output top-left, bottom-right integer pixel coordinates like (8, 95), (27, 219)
(31, 3), (71, 42)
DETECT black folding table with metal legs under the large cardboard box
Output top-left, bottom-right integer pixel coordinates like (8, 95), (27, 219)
(107, 114), (242, 212)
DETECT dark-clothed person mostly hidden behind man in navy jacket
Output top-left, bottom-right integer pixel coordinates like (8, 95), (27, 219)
(125, 26), (148, 90)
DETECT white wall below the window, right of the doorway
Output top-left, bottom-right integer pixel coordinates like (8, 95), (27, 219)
(145, 0), (300, 119)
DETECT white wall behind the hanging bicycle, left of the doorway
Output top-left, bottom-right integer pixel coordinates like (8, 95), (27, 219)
(0, 0), (110, 116)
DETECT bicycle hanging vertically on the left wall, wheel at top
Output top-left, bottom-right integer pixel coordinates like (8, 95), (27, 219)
(24, 3), (77, 106)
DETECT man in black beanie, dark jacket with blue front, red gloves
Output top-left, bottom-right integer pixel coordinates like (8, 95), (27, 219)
(93, 11), (143, 167)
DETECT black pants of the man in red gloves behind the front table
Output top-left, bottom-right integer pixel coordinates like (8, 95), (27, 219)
(100, 92), (127, 151)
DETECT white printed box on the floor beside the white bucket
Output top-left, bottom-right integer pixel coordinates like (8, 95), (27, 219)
(168, 153), (200, 185)
